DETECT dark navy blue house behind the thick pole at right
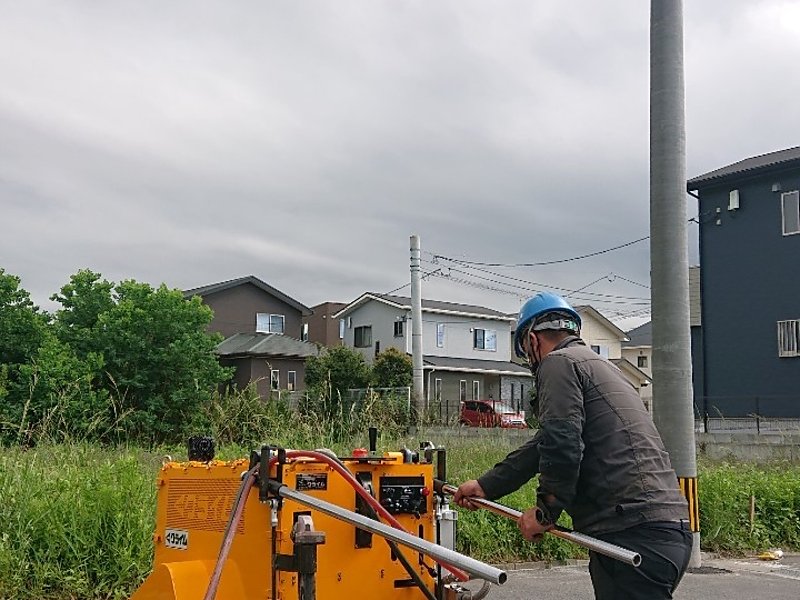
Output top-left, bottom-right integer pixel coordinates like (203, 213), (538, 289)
(686, 147), (800, 417)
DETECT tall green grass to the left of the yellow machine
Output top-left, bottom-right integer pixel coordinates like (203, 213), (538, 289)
(0, 445), (159, 599)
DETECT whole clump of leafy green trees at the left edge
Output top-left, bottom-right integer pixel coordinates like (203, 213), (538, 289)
(0, 270), (230, 444)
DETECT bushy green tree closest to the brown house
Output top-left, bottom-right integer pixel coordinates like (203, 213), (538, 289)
(53, 271), (230, 442)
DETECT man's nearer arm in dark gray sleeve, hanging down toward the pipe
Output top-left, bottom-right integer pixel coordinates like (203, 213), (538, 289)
(537, 355), (585, 522)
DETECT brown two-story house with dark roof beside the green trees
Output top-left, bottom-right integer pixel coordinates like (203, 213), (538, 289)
(184, 275), (318, 397)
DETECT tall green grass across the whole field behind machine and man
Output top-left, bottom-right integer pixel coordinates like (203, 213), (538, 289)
(0, 434), (800, 600)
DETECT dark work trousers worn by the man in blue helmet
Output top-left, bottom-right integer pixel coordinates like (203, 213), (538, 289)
(589, 521), (692, 600)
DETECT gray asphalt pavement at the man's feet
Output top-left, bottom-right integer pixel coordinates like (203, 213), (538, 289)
(468, 553), (800, 600)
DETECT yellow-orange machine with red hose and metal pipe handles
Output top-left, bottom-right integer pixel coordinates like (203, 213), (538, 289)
(132, 428), (638, 600)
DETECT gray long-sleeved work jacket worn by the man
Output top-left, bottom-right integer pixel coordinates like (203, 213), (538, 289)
(478, 336), (689, 535)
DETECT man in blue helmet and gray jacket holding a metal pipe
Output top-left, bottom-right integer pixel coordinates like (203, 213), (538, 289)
(454, 292), (692, 600)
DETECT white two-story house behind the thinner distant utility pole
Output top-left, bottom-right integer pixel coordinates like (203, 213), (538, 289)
(335, 292), (531, 422)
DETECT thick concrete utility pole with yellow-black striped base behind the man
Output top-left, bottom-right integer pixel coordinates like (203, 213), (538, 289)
(650, 0), (700, 567)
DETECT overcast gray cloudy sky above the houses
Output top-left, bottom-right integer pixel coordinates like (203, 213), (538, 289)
(0, 0), (800, 327)
